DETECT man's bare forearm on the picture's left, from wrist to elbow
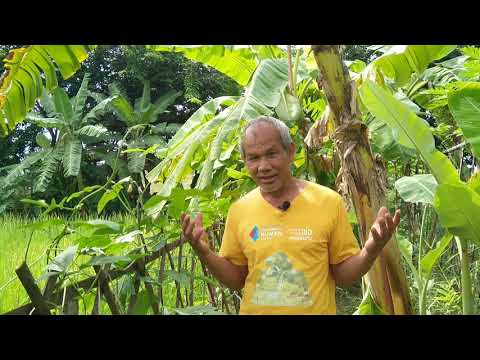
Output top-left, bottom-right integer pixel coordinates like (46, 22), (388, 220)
(197, 250), (248, 290)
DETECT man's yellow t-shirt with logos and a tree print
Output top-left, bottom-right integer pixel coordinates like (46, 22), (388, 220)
(219, 182), (360, 314)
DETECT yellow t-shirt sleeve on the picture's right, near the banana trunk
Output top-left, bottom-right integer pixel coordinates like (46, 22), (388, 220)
(328, 197), (360, 264)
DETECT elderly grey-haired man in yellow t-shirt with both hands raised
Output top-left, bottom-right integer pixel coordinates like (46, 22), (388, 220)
(181, 117), (400, 314)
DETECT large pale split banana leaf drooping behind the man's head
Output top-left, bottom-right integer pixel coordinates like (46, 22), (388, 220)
(147, 59), (298, 217)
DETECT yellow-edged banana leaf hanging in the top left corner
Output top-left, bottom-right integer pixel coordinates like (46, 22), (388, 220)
(0, 45), (95, 136)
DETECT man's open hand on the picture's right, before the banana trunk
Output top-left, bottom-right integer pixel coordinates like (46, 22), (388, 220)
(365, 206), (400, 257)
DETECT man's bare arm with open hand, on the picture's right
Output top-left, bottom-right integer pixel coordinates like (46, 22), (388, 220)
(331, 207), (400, 286)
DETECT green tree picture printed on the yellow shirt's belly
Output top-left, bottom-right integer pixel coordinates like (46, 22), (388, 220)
(251, 252), (313, 306)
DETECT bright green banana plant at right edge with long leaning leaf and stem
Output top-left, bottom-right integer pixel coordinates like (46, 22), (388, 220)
(359, 80), (480, 314)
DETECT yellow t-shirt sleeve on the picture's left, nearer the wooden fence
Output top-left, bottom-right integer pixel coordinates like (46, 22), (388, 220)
(218, 206), (248, 265)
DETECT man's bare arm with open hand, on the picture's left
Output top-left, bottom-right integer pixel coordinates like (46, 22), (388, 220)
(181, 214), (248, 290)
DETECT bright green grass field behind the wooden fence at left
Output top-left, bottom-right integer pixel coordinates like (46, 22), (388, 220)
(0, 215), (361, 314)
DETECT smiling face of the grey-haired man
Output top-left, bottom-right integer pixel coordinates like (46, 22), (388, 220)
(243, 123), (295, 193)
